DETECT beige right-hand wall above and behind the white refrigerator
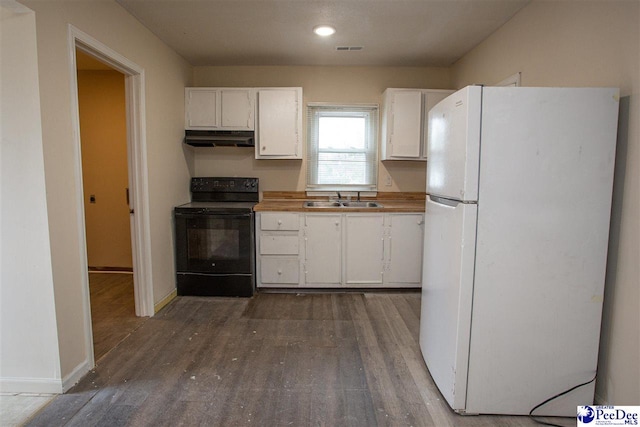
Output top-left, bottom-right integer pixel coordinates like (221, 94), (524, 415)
(452, 0), (640, 405)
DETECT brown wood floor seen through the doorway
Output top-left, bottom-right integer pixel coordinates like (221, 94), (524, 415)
(89, 273), (146, 362)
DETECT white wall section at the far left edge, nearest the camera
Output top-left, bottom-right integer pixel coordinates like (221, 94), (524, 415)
(0, 1), (62, 393)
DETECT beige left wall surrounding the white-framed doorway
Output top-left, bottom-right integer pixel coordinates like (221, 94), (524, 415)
(22, 0), (192, 383)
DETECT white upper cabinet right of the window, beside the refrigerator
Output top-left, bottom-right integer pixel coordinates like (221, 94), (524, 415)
(382, 88), (453, 161)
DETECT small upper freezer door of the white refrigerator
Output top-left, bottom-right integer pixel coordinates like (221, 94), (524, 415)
(427, 86), (482, 201)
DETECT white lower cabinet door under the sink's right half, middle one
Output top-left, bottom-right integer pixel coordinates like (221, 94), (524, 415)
(345, 213), (384, 287)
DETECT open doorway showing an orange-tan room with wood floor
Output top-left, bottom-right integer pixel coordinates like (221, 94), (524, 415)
(76, 49), (144, 360)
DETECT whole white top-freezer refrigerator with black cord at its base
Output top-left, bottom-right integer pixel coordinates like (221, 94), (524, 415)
(420, 86), (619, 417)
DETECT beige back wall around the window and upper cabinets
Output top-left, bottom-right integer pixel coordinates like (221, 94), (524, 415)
(191, 66), (451, 191)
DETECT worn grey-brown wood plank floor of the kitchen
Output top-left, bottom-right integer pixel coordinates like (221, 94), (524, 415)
(27, 293), (575, 427)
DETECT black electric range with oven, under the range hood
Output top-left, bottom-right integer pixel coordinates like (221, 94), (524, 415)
(174, 177), (260, 297)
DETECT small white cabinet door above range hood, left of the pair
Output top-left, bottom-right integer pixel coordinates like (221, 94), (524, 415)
(184, 88), (220, 129)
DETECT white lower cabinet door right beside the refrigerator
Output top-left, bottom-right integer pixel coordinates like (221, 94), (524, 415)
(385, 213), (424, 287)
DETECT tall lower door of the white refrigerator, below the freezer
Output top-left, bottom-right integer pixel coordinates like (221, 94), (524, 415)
(420, 196), (477, 412)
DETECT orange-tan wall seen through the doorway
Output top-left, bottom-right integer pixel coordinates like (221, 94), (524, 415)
(78, 71), (133, 268)
